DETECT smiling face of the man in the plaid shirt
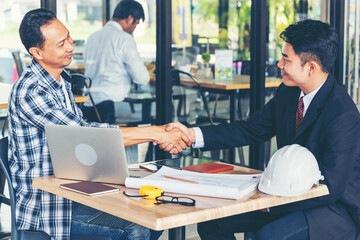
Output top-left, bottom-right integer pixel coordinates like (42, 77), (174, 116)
(39, 19), (74, 69)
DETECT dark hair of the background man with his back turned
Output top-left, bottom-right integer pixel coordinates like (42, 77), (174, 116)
(113, 0), (145, 22)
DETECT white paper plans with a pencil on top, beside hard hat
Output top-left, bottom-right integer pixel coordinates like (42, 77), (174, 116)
(125, 166), (261, 199)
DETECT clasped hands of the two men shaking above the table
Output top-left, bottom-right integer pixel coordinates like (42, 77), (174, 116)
(154, 125), (191, 154)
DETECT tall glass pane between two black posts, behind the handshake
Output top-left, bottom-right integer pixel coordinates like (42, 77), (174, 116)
(172, 0), (251, 163)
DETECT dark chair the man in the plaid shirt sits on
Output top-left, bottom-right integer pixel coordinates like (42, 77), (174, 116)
(0, 137), (111, 240)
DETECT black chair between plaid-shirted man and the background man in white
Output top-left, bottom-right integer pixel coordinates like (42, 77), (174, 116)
(71, 73), (102, 123)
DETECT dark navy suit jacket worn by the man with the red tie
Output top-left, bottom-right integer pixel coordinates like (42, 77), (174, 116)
(201, 76), (360, 240)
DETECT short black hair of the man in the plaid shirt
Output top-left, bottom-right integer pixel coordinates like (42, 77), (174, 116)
(19, 8), (56, 53)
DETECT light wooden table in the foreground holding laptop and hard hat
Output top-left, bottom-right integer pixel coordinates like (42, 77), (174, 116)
(32, 166), (329, 239)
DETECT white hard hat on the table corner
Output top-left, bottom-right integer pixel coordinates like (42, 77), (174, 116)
(259, 144), (324, 197)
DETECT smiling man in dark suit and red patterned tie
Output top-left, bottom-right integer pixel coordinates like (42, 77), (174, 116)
(161, 20), (360, 240)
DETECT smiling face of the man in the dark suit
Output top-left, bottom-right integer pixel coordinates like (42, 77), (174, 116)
(277, 42), (309, 89)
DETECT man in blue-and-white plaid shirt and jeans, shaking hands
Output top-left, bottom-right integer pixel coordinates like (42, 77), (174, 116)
(8, 9), (191, 239)
